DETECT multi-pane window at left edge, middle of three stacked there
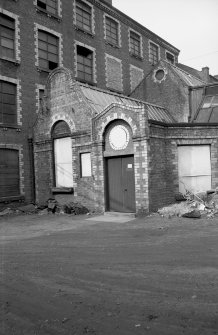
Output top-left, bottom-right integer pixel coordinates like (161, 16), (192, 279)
(0, 81), (17, 125)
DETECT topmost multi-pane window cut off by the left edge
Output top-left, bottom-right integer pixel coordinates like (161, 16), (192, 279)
(0, 14), (15, 58)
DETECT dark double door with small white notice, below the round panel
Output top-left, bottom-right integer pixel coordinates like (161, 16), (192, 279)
(107, 156), (135, 212)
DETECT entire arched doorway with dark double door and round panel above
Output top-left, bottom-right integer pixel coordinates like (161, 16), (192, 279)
(104, 120), (136, 212)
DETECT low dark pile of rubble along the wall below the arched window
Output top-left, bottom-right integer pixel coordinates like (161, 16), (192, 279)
(0, 198), (89, 217)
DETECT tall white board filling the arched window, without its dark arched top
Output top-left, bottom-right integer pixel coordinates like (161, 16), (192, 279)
(54, 137), (73, 187)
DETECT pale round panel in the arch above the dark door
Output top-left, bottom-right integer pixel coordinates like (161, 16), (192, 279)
(109, 125), (129, 150)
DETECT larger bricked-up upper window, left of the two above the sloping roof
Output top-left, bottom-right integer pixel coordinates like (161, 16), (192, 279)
(106, 55), (123, 92)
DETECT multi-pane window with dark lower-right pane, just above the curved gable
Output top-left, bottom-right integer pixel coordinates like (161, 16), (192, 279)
(38, 30), (59, 70)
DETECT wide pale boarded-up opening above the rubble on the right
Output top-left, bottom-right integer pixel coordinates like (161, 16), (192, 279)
(178, 145), (211, 193)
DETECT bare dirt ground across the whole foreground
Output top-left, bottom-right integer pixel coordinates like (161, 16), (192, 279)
(0, 215), (218, 335)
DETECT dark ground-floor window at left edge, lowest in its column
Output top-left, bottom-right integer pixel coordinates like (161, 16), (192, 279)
(0, 149), (20, 198)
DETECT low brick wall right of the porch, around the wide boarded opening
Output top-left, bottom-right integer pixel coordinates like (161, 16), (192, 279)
(149, 125), (218, 211)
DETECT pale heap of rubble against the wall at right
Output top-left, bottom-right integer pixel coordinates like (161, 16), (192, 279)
(158, 188), (218, 219)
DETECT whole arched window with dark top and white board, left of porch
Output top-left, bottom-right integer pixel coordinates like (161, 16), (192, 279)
(52, 121), (73, 188)
